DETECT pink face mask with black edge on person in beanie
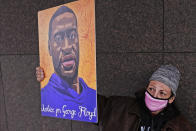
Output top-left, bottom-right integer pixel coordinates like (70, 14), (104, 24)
(145, 91), (168, 112)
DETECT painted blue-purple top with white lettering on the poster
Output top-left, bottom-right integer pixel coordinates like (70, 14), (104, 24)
(41, 73), (97, 123)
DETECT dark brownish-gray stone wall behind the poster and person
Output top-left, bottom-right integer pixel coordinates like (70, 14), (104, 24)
(0, 0), (196, 131)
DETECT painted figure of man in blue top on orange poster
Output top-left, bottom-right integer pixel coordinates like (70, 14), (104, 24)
(39, 0), (97, 122)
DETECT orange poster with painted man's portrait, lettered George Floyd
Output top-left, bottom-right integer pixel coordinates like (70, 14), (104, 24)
(38, 0), (97, 123)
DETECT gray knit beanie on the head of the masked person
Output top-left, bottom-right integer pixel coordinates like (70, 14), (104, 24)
(150, 65), (180, 96)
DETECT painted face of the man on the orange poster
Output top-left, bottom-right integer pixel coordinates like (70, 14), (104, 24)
(49, 12), (79, 79)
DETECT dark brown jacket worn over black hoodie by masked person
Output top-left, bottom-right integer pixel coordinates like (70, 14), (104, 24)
(98, 92), (192, 131)
